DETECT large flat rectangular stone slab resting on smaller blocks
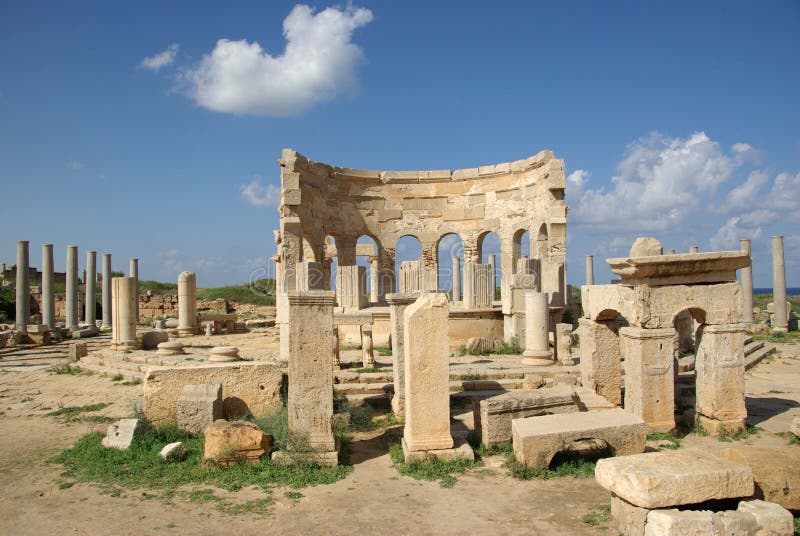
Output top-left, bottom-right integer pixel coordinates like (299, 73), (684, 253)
(594, 450), (753, 508)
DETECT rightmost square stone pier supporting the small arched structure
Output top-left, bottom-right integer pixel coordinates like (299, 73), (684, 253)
(695, 322), (748, 435)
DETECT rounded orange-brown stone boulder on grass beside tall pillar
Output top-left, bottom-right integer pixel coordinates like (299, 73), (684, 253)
(203, 419), (272, 465)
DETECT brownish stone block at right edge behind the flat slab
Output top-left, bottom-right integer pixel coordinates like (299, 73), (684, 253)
(722, 447), (800, 510)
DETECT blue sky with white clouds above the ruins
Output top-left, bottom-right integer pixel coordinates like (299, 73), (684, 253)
(0, 1), (800, 286)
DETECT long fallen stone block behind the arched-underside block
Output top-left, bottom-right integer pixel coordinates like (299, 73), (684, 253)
(472, 386), (578, 447)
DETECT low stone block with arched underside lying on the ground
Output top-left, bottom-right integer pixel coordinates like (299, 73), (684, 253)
(511, 408), (647, 466)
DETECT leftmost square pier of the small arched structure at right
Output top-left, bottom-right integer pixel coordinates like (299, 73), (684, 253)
(579, 318), (622, 406)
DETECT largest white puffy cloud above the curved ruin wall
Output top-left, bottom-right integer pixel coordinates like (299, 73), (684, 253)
(181, 4), (372, 116)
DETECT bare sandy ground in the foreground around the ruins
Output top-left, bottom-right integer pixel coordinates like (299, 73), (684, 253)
(0, 333), (800, 535)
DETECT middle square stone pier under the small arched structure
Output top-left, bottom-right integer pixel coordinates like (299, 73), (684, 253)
(619, 327), (677, 432)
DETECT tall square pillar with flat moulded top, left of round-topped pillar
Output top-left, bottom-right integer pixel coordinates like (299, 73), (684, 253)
(280, 290), (338, 466)
